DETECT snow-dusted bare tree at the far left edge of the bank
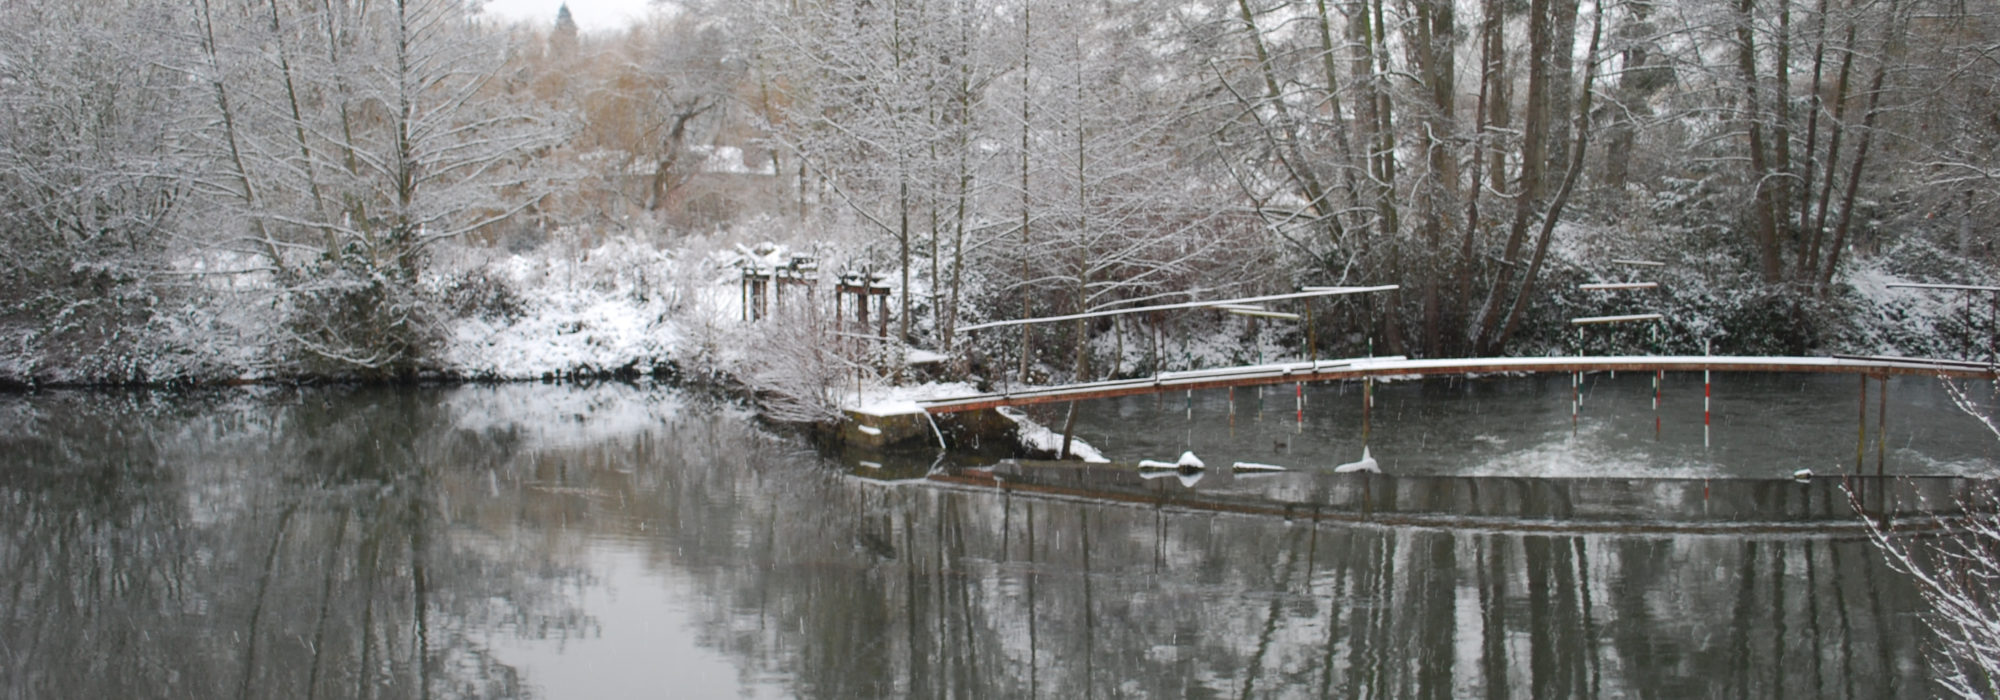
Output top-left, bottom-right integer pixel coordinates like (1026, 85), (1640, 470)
(0, 0), (198, 380)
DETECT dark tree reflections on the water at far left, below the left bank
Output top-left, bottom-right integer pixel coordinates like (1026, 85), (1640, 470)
(0, 390), (590, 698)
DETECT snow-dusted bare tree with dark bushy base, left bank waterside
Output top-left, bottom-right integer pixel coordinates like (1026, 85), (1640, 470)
(194, 0), (564, 376)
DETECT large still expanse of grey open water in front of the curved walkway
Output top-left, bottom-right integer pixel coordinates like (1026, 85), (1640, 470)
(0, 380), (1982, 698)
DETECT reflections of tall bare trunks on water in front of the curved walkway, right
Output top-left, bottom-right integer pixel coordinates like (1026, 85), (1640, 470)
(628, 454), (1924, 698)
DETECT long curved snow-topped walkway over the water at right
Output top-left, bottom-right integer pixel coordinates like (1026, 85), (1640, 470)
(916, 356), (2000, 414)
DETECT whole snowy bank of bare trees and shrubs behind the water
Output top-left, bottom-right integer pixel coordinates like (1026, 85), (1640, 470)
(0, 0), (2000, 388)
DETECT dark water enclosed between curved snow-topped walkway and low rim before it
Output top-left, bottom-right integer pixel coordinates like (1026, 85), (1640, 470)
(1034, 372), (2000, 478)
